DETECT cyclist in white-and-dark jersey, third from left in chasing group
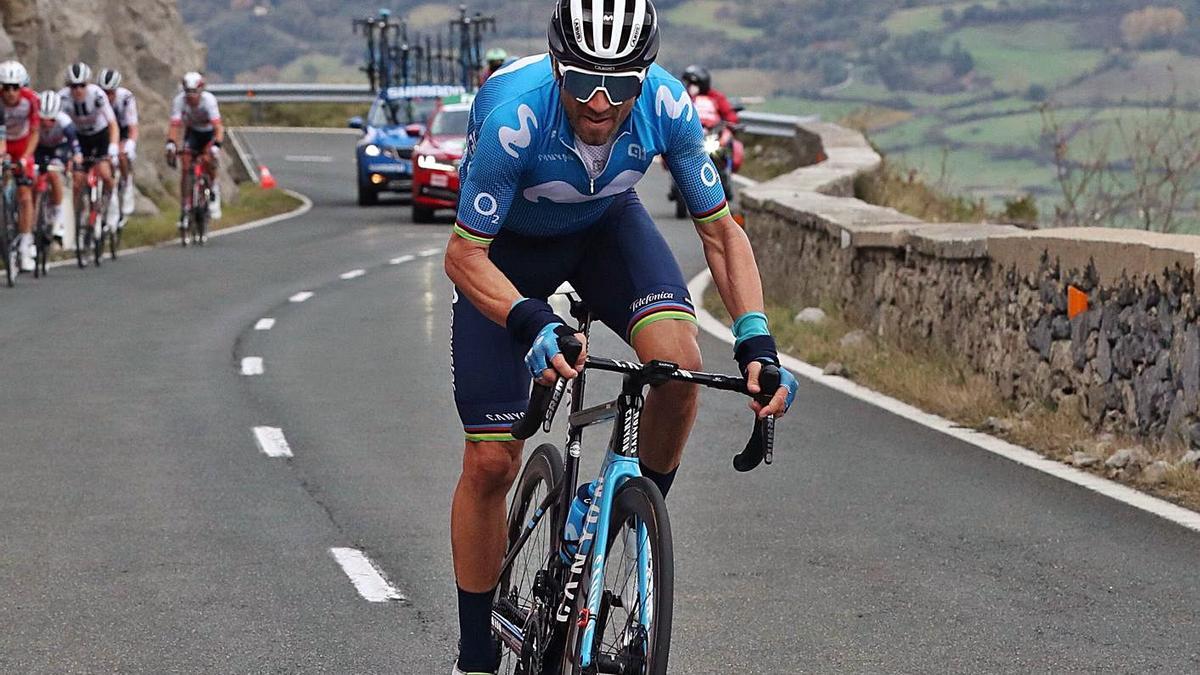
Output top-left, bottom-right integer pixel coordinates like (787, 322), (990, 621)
(59, 62), (121, 227)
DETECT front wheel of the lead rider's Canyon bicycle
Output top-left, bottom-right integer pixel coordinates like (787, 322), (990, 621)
(563, 477), (674, 675)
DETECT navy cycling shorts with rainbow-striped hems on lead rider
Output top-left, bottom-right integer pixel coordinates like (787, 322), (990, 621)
(451, 190), (696, 441)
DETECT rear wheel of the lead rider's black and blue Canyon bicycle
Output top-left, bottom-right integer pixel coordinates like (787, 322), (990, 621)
(493, 443), (563, 675)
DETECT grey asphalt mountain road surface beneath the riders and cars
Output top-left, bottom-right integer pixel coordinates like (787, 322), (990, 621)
(0, 128), (1200, 674)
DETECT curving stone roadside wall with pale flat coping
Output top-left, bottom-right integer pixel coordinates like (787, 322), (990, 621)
(743, 124), (1200, 443)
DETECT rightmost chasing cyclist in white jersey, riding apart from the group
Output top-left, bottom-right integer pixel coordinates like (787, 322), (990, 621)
(167, 72), (224, 220)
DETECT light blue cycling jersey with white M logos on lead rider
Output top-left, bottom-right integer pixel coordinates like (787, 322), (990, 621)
(455, 54), (728, 244)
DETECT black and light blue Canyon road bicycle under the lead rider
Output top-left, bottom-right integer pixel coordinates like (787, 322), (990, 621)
(492, 294), (779, 675)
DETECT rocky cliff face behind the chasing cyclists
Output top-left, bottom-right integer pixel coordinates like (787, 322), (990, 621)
(0, 0), (204, 196)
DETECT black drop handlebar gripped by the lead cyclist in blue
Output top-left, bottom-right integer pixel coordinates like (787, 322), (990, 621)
(512, 335), (781, 473)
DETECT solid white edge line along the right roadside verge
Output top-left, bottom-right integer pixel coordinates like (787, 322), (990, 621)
(688, 266), (1200, 532)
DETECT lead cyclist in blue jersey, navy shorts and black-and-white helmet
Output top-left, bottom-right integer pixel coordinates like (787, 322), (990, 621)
(445, 0), (797, 674)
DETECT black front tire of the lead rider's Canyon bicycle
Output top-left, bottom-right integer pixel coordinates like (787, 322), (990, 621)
(562, 477), (674, 675)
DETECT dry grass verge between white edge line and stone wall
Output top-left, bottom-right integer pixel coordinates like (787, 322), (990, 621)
(703, 287), (1200, 510)
